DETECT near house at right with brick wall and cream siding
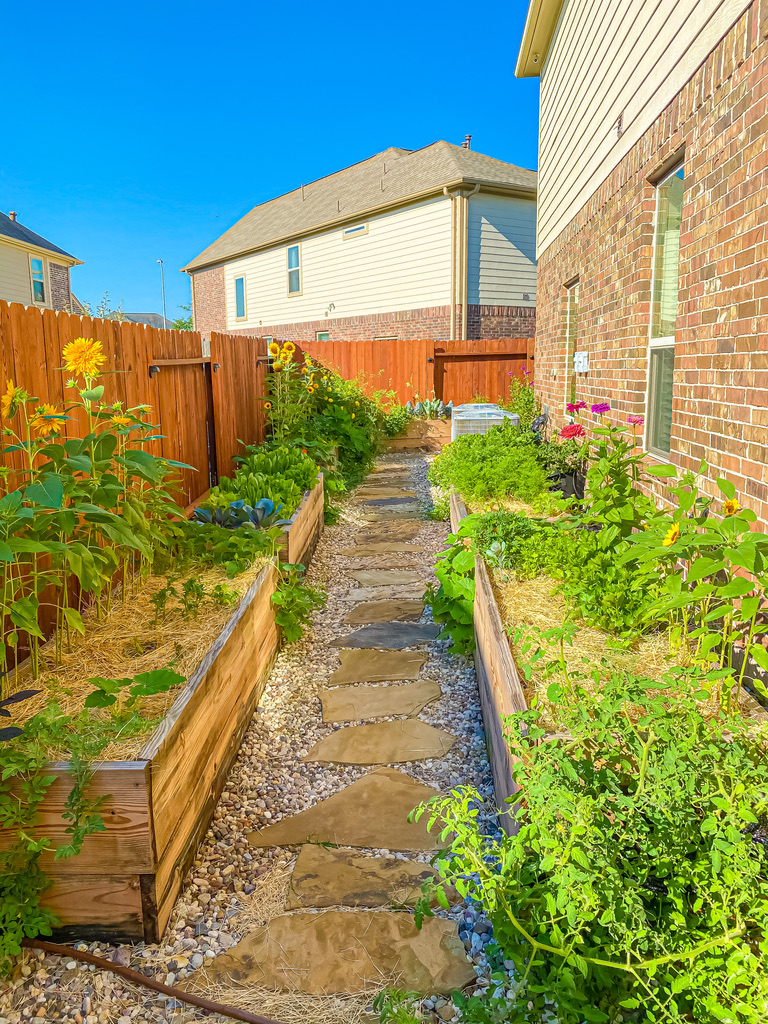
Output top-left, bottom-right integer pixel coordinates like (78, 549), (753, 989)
(516, 0), (768, 522)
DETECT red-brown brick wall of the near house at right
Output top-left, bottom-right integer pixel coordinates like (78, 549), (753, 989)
(537, 0), (768, 523)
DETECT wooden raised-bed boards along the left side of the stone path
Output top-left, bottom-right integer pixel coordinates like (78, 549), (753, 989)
(9, 481), (323, 942)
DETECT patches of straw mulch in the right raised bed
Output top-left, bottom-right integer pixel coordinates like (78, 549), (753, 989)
(489, 568), (766, 727)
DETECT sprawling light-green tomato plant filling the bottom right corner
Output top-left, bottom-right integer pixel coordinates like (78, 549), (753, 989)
(422, 671), (768, 1024)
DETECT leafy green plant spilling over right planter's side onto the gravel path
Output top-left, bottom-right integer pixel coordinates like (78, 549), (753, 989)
(424, 524), (475, 654)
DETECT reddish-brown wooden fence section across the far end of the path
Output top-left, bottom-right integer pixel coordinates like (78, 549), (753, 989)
(301, 338), (534, 406)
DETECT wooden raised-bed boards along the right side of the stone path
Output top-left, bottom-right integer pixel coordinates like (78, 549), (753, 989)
(451, 495), (528, 835)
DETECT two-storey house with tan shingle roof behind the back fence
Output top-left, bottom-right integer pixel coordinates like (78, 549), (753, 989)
(184, 137), (536, 341)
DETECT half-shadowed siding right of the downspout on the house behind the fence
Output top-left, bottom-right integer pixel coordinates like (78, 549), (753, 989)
(467, 194), (536, 306)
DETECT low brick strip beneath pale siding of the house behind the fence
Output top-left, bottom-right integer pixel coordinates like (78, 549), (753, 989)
(214, 303), (536, 342)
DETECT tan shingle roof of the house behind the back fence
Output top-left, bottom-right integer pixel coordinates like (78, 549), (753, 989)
(182, 141), (537, 271)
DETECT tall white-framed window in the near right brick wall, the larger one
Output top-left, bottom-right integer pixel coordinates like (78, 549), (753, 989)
(646, 166), (683, 456)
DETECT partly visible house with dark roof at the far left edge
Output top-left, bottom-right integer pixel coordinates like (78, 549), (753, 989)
(0, 211), (83, 312)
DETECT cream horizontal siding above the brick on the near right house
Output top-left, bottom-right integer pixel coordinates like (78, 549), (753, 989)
(538, 0), (750, 254)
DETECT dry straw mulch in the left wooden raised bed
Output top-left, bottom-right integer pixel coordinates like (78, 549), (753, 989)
(10, 558), (268, 761)
